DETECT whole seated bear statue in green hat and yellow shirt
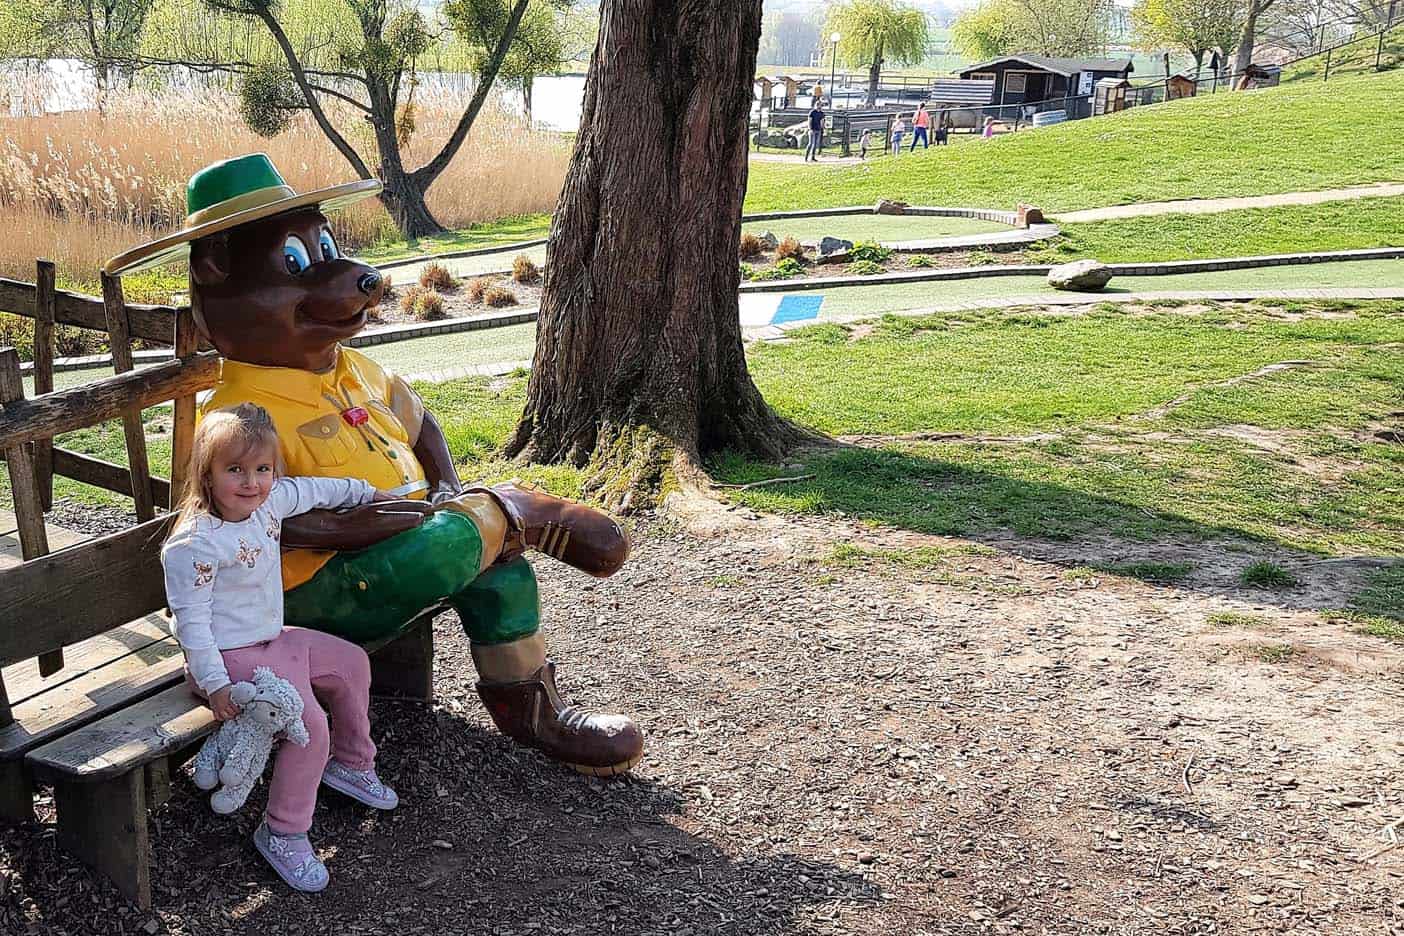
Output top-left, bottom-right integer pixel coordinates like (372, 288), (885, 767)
(105, 154), (643, 776)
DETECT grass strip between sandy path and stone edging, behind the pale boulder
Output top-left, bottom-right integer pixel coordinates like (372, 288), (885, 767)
(1025, 198), (1404, 264)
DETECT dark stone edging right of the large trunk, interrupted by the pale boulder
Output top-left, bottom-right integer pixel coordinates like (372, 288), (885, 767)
(740, 247), (1404, 295)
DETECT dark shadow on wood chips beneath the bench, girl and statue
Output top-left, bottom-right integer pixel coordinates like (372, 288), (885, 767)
(0, 702), (879, 936)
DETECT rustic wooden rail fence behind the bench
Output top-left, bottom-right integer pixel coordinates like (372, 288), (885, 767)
(0, 260), (219, 687)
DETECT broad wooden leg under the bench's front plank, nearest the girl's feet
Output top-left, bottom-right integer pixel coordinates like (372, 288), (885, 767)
(53, 769), (152, 909)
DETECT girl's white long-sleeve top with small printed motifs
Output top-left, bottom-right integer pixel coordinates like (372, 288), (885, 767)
(161, 477), (375, 695)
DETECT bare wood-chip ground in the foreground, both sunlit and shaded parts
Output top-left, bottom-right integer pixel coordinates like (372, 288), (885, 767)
(0, 505), (1404, 936)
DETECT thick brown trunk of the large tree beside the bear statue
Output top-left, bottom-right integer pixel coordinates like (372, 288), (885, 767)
(508, 0), (802, 509)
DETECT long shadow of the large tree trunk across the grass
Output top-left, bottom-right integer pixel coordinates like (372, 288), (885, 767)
(719, 445), (1404, 610)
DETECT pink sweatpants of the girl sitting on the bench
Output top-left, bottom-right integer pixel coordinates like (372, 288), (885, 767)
(185, 627), (375, 835)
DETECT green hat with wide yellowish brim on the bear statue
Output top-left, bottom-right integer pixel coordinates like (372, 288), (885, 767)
(102, 153), (383, 276)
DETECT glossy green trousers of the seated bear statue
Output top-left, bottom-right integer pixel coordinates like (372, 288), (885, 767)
(284, 511), (541, 644)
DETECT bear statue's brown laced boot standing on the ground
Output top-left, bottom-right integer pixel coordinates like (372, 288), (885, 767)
(473, 634), (643, 777)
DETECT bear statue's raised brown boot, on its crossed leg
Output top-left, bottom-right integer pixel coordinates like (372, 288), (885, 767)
(468, 481), (629, 578)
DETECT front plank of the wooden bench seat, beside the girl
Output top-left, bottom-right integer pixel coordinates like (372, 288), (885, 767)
(25, 681), (218, 783)
